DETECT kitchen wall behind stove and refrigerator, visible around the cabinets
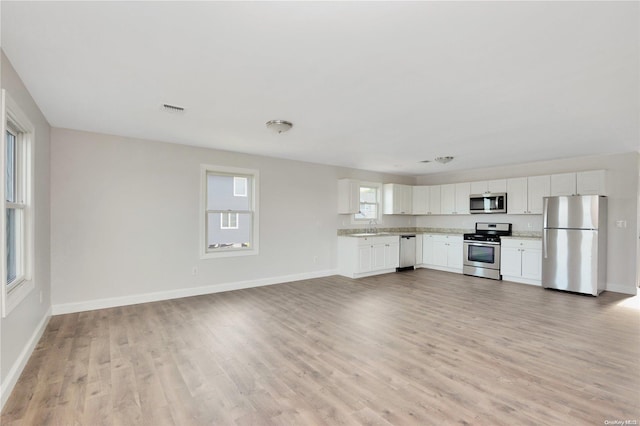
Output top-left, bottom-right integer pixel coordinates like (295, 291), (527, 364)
(416, 152), (640, 294)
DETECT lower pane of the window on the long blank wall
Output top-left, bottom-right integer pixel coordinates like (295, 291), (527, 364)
(207, 212), (252, 250)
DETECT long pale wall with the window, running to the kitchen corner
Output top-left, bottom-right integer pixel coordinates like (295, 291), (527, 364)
(51, 128), (413, 313)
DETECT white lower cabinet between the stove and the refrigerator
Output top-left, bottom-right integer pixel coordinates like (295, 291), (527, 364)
(500, 238), (542, 285)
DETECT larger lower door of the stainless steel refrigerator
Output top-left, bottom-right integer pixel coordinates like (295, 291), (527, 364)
(542, 229), (606, 296)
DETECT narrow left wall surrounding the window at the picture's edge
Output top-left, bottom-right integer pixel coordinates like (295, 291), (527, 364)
(0, 52), (51, 404)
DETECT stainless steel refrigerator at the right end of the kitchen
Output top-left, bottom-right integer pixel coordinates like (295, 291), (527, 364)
(542, 195), (607, 296)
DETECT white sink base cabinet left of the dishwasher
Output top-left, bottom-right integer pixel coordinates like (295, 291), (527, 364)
(338, 236), (400, 278)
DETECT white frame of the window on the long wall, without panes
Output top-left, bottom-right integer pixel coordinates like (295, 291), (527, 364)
(198, 164), (260, 259)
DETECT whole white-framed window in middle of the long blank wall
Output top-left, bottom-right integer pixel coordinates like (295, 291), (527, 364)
(201, 166), (258, 258)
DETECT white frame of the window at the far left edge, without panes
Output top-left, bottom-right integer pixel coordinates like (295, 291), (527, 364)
(0, 89), (35, 317)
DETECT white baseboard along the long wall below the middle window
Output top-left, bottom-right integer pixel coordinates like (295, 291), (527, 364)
(53, 270), (337, 315)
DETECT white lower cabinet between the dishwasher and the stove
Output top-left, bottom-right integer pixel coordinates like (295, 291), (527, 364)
(421, 234), (463, 273)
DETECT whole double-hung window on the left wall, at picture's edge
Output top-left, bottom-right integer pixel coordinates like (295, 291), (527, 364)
(0, 90), (33, 316)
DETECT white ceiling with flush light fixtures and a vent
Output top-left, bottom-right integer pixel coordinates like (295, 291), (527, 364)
(1, 1), (640, 175)
